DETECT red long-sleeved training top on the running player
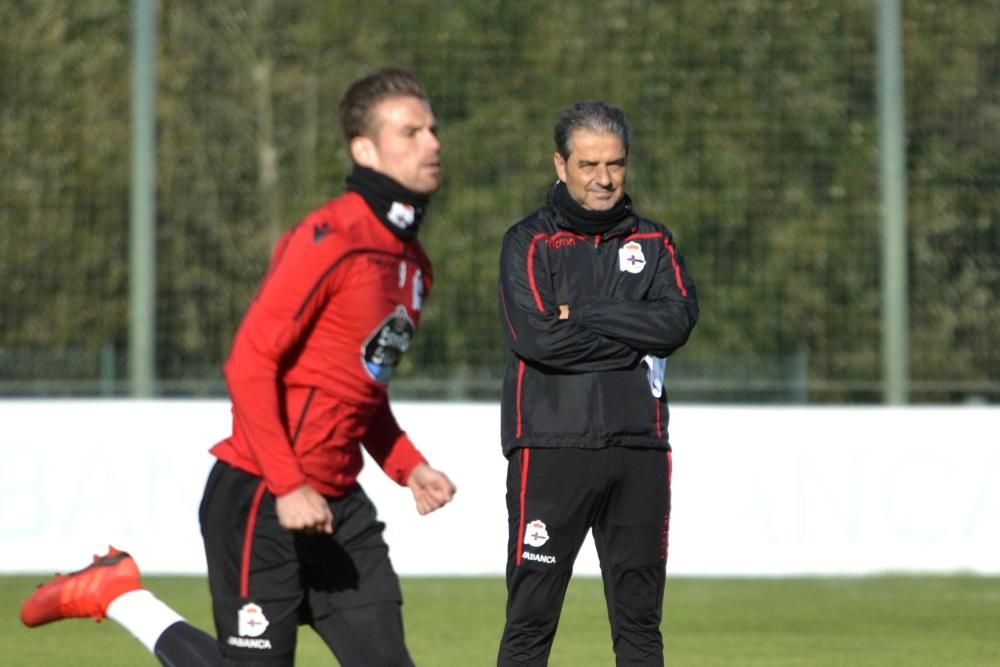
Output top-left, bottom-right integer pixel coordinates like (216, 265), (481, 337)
(212, 192), (431, 496)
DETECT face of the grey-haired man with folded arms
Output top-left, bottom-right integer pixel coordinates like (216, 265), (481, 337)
(554, 130), (626, 211)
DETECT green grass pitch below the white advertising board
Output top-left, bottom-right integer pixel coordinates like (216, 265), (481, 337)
(0, 576), (1000, 667)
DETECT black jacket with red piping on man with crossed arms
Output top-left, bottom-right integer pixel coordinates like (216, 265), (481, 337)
(499, 191), (698, 456)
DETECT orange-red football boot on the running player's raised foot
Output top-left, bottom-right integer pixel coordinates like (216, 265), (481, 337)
(21, 547), (142, 628)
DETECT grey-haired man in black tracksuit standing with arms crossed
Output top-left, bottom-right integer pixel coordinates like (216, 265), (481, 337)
(497, 102), (698, 667)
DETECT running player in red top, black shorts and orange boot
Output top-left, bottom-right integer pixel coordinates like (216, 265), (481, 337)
(21, 70), (455, 667)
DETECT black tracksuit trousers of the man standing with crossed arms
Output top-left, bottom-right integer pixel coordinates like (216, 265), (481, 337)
(497, 447), (671, 667)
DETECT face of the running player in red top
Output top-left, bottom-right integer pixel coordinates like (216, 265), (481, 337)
(351, 95), (441, 195)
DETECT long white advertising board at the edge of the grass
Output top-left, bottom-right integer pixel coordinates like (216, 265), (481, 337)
(0, 400), (1000, 576)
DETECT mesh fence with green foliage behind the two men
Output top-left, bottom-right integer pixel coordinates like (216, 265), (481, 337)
(0, 0), (1000, 402)
